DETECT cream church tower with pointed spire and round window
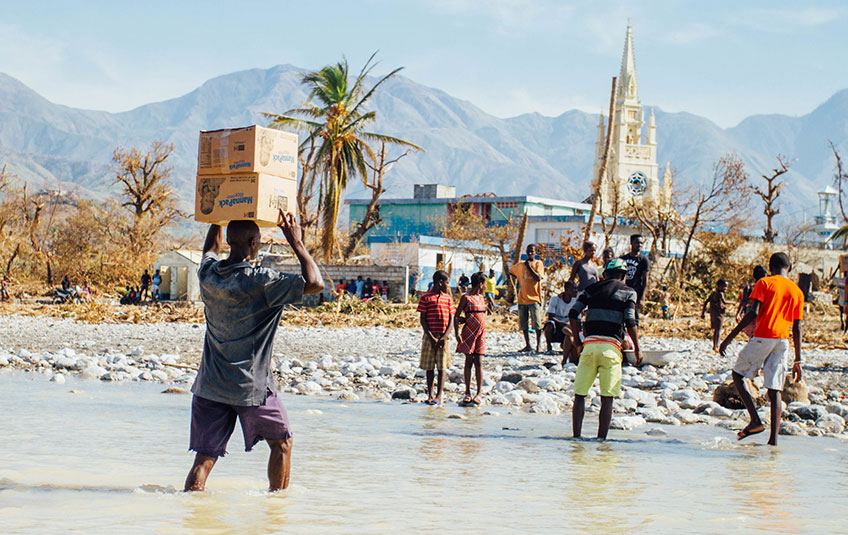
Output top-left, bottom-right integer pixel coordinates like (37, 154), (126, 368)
(592, 20), (663, 215)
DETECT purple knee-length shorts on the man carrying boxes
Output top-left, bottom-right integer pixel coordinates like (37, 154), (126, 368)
(189, 389), (292, 457)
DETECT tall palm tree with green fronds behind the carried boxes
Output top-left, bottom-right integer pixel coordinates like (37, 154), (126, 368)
(264, 52), (421, 262)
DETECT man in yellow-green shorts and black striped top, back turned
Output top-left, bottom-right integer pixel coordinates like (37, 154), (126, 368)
(568, 258), (642, 439)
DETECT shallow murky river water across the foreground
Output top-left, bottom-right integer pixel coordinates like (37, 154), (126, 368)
(0, 373), (848, 534)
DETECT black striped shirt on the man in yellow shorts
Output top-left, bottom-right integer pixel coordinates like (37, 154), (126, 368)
(568, 279), (636, 342)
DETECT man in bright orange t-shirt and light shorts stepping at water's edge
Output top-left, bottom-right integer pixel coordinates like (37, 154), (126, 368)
(719, 253), (804, 446)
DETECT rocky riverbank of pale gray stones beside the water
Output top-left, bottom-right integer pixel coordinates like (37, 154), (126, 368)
(0, 316), (848, 439)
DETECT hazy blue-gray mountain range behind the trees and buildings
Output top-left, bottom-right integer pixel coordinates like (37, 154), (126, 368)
(0, 65), (848, 222)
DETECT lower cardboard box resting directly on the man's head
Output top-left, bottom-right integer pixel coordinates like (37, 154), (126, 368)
(194, 173), (297, 227)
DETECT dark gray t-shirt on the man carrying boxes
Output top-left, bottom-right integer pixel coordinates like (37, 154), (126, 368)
(191, 253), (305, 406)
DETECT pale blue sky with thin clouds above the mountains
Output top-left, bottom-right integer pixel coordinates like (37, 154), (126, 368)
(0, 0), (848, 127)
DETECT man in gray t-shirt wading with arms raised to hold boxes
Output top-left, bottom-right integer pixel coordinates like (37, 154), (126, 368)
(185, 212), (324, 491)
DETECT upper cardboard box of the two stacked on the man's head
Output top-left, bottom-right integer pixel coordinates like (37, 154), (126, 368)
(197, 125), (297, 180)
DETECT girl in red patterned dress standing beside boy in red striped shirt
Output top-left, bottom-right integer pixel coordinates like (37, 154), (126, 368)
(454, 273), (487, 405)
